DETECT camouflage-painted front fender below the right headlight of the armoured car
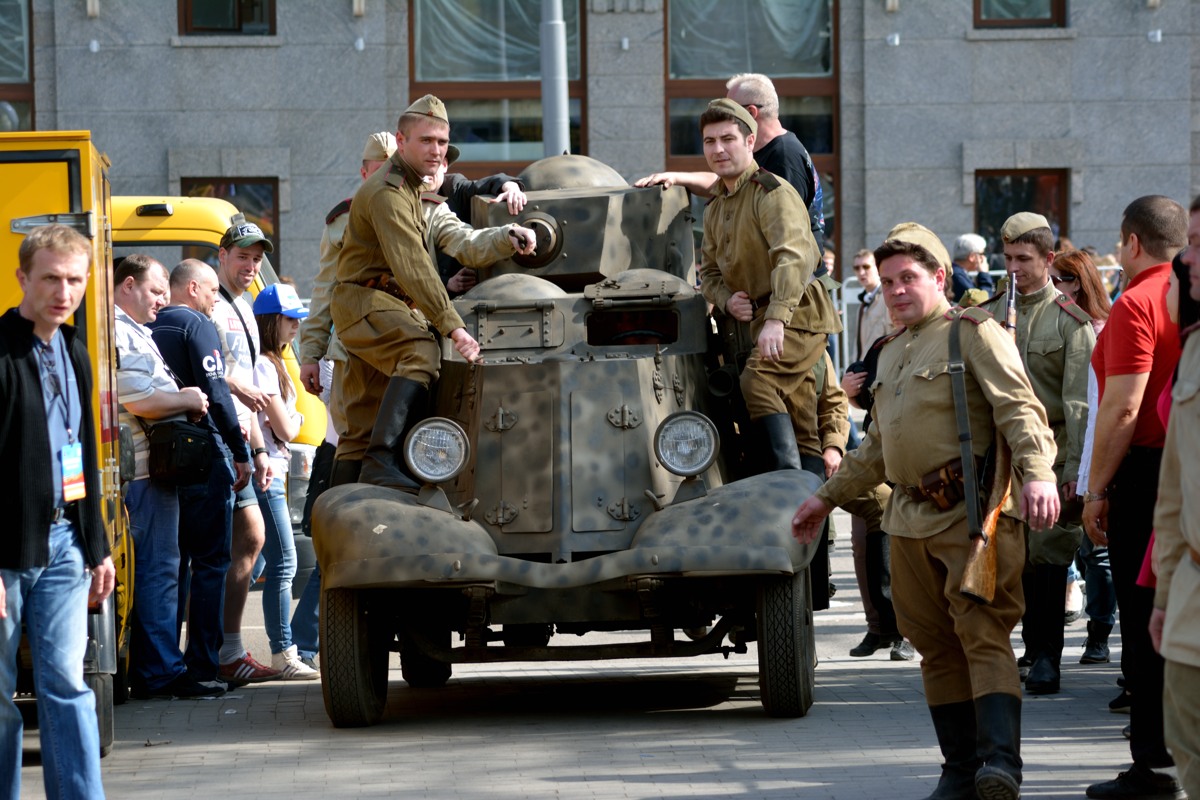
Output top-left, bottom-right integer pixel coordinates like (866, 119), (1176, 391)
(632, 469), (821, 572)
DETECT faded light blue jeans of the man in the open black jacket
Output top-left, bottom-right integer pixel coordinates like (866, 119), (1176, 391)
(0, 522), (104, 800)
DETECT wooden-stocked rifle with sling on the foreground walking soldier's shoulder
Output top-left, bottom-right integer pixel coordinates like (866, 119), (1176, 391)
(950, 275), (1016, 606)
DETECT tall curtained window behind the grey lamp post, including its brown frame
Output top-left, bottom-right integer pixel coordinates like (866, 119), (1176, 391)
(409, 0), (586, 176)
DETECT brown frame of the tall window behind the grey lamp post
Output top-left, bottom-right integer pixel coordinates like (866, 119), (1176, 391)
(408, 0), (588, 180)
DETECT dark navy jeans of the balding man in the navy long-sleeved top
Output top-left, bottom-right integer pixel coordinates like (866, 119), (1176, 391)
(175, 457), (233, 680)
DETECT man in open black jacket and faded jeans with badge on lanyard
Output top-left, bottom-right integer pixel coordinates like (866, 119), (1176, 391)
(0, 225), (116, 798)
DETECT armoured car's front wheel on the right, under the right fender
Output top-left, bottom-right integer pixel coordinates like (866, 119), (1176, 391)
(756, 569), (816, 717)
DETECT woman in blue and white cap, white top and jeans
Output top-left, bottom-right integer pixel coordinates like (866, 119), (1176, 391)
(254, 283), (320, 680)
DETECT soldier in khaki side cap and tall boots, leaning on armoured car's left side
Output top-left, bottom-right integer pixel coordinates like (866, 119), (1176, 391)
(332, 95), (533, 489)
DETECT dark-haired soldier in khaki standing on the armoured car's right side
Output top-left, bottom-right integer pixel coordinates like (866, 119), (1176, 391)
(700, 98), (841, 469)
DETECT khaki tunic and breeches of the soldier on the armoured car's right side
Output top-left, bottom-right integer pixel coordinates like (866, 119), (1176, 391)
(700, 162), (841, 420)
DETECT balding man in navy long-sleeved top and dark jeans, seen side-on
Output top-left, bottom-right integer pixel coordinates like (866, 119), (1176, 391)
(149, 258), (252, 681)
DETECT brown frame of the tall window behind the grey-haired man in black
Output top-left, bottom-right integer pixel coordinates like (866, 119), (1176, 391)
(662, 0), (842, 253)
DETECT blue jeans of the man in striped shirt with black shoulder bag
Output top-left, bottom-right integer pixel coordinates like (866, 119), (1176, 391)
(125, 479), (187, 688)
